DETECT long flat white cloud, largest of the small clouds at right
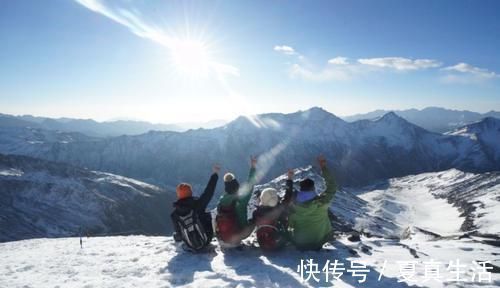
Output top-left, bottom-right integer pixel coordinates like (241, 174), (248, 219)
(358, 57), (442, 71)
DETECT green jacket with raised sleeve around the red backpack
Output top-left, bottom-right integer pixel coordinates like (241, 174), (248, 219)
(217, 168), (256, 228)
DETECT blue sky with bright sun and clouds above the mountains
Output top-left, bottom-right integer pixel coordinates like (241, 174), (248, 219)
(0, 0), (500, 122)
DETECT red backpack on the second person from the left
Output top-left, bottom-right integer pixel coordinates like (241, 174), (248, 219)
(215, 201), (241, 243)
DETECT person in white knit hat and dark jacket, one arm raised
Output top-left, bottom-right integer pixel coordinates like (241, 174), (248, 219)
(252, 170), (293, 251)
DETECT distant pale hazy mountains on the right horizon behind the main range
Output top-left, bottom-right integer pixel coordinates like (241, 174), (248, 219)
(342, 107), (500, 133)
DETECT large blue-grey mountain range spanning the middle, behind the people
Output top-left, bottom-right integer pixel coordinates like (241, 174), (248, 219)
(0, 108), (500, 187)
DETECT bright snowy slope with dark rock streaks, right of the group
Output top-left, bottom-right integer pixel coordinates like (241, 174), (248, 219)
(348, 169), (500, 239)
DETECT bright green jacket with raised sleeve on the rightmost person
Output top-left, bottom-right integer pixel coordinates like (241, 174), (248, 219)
(288, 168), (337, 250)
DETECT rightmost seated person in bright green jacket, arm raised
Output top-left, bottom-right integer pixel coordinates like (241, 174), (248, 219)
(288, 156), (337, 250)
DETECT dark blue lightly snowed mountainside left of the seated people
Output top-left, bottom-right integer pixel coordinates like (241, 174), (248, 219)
(0, 154), (173, 242)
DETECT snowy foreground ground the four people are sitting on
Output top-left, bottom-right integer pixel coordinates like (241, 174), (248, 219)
(0, 236), (500, 288)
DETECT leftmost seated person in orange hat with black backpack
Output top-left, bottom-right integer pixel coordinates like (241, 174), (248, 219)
(170, 164), (220, 252)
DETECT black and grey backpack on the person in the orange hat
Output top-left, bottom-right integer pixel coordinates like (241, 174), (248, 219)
(173, 210), (208, 251)
